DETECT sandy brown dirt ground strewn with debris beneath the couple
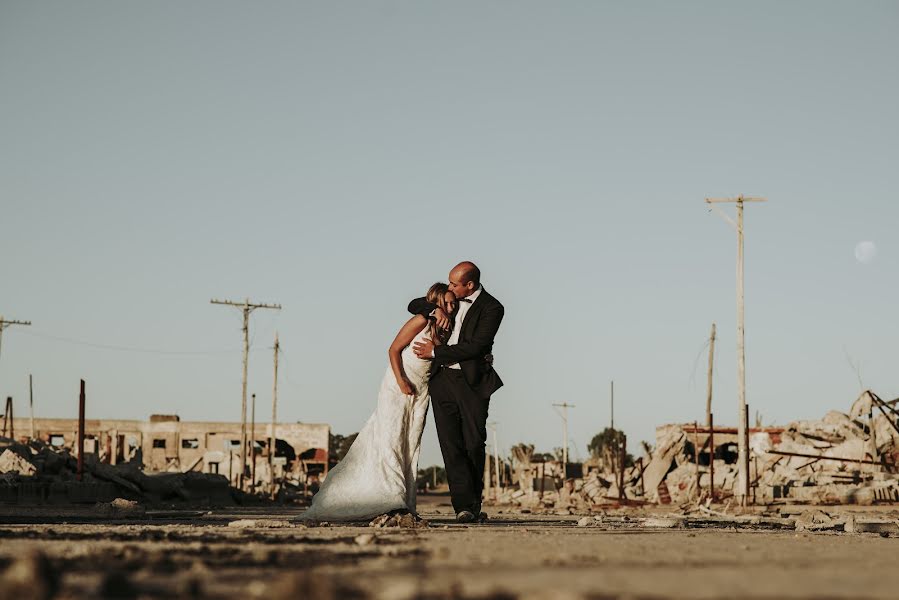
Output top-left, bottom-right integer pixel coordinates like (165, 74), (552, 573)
(0, 496), (899, 600)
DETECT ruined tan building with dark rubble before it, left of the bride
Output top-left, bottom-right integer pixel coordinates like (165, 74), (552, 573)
(0, 415), (330, 502)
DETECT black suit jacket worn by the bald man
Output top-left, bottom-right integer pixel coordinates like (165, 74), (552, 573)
(409, 287), (505, 398)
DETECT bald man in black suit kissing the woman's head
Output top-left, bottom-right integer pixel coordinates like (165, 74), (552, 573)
(409, 261), (505, 523)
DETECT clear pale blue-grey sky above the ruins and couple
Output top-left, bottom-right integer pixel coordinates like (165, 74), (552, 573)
(0, 0), (899, 465)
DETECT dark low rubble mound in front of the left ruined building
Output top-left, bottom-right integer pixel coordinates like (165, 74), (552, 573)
(0, 437), (243, 510)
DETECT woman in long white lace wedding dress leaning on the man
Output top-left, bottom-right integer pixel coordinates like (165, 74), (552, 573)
(300, 283), (456, 521)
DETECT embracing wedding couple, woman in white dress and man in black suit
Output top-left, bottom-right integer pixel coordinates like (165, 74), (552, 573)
(300, 262), (504, 523)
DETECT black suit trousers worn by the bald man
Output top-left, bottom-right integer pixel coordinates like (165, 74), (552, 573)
(430, 367), (490, 516)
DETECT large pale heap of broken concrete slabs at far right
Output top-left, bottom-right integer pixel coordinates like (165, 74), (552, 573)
(643, 391), (899, 505)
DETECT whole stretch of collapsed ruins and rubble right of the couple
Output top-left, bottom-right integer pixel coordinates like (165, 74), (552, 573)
(497, 390), (899, 509)
